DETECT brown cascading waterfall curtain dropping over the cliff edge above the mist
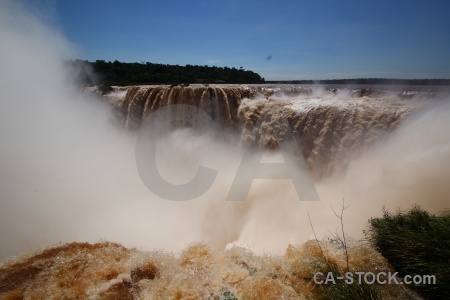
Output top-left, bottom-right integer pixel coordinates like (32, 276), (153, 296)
(120, 86), (420, 178)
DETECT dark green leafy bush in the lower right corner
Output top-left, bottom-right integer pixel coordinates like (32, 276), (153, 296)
(365, 206), (450, 299)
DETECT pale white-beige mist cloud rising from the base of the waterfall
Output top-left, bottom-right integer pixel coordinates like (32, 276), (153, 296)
(0, 1), (450, 259)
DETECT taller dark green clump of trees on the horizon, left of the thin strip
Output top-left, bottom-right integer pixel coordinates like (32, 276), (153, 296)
(68, 60), (264, 86)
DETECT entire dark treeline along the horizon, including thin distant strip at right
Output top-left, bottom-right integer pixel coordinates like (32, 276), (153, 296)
(66, 60), (450, 86)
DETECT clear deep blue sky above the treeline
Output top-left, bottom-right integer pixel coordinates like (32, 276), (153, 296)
(33, 0), (450, 80)
